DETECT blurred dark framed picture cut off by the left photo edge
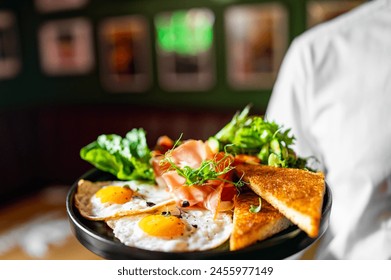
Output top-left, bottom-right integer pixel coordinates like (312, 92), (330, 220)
(0, 11), (21, 80)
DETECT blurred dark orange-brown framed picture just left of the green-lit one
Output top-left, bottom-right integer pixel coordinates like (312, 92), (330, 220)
(99, 15), (152, 92)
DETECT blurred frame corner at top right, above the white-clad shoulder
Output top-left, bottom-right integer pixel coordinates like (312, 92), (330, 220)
(307, 0), (366, 28)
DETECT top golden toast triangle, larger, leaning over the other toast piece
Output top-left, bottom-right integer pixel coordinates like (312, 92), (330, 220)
(236, 164), (326, 238)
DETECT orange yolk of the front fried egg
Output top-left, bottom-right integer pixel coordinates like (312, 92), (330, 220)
(139, 215), (185, 239)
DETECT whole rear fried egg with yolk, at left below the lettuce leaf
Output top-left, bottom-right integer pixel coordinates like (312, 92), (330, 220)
(75, 180), (174, 220)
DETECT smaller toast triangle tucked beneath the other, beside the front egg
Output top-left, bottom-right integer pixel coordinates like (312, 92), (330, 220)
(229, 191), (292, 251)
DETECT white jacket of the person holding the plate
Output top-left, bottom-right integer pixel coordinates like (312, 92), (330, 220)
(266, 0), (391, 259)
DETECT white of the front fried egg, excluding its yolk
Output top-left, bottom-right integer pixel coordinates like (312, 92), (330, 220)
(107, 210), (232, 252)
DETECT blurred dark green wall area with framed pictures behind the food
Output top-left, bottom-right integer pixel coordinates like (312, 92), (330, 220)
(0, 0), (364, 206)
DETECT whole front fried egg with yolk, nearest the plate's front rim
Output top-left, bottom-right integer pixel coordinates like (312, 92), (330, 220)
(107, 206), (232, 252)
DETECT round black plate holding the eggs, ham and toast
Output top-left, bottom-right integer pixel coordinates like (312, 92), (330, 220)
(66, 169), (332, 260)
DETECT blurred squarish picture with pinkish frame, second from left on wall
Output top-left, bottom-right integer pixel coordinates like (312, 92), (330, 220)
(38, 18), (94, 76)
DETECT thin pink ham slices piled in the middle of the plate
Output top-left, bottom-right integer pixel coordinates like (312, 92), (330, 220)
(152, 140), (237, 214)
